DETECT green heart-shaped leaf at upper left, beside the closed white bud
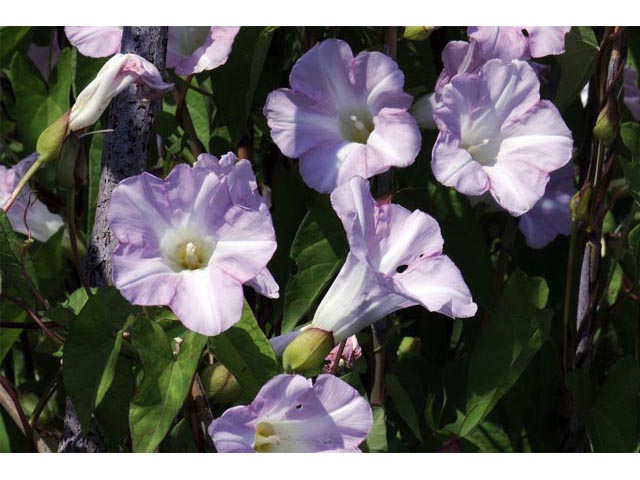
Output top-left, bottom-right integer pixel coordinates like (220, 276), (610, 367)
(10, 49), (72, 152)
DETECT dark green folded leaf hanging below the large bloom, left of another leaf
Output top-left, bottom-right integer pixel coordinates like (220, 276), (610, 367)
(62, 288), (132, 433)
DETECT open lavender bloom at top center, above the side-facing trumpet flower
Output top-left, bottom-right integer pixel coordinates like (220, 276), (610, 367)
(264, 40), (420, 192)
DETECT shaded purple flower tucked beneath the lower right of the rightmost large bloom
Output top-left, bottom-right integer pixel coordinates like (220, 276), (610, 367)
(519, 163), (577, 248)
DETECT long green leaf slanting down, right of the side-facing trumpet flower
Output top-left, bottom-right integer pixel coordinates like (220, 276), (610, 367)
(461, 270), (553, 436)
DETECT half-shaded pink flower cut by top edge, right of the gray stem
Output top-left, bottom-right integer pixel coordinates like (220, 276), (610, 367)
(167, 27), (240, 75)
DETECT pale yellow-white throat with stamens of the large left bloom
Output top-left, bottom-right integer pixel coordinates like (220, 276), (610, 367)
(160, 230), (217, 272)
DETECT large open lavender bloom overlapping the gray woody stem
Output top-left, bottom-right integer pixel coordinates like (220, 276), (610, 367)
(108, 156), (276, 335)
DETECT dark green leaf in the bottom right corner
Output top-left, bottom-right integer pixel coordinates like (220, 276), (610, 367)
(585, 356), (640, 452)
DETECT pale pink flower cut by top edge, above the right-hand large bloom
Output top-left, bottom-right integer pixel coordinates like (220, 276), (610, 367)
(467, 26), (571, 61)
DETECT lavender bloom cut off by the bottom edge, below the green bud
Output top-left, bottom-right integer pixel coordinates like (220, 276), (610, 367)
(209, 375), (373, 453)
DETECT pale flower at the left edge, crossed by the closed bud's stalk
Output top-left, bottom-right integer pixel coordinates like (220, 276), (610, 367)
(0, 153), (64, 242)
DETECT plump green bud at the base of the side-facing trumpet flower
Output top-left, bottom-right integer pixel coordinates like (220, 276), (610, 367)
(282, 328), (335, 373)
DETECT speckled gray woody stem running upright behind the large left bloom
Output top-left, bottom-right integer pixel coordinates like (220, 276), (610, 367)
(58, 27), (167, 452)
